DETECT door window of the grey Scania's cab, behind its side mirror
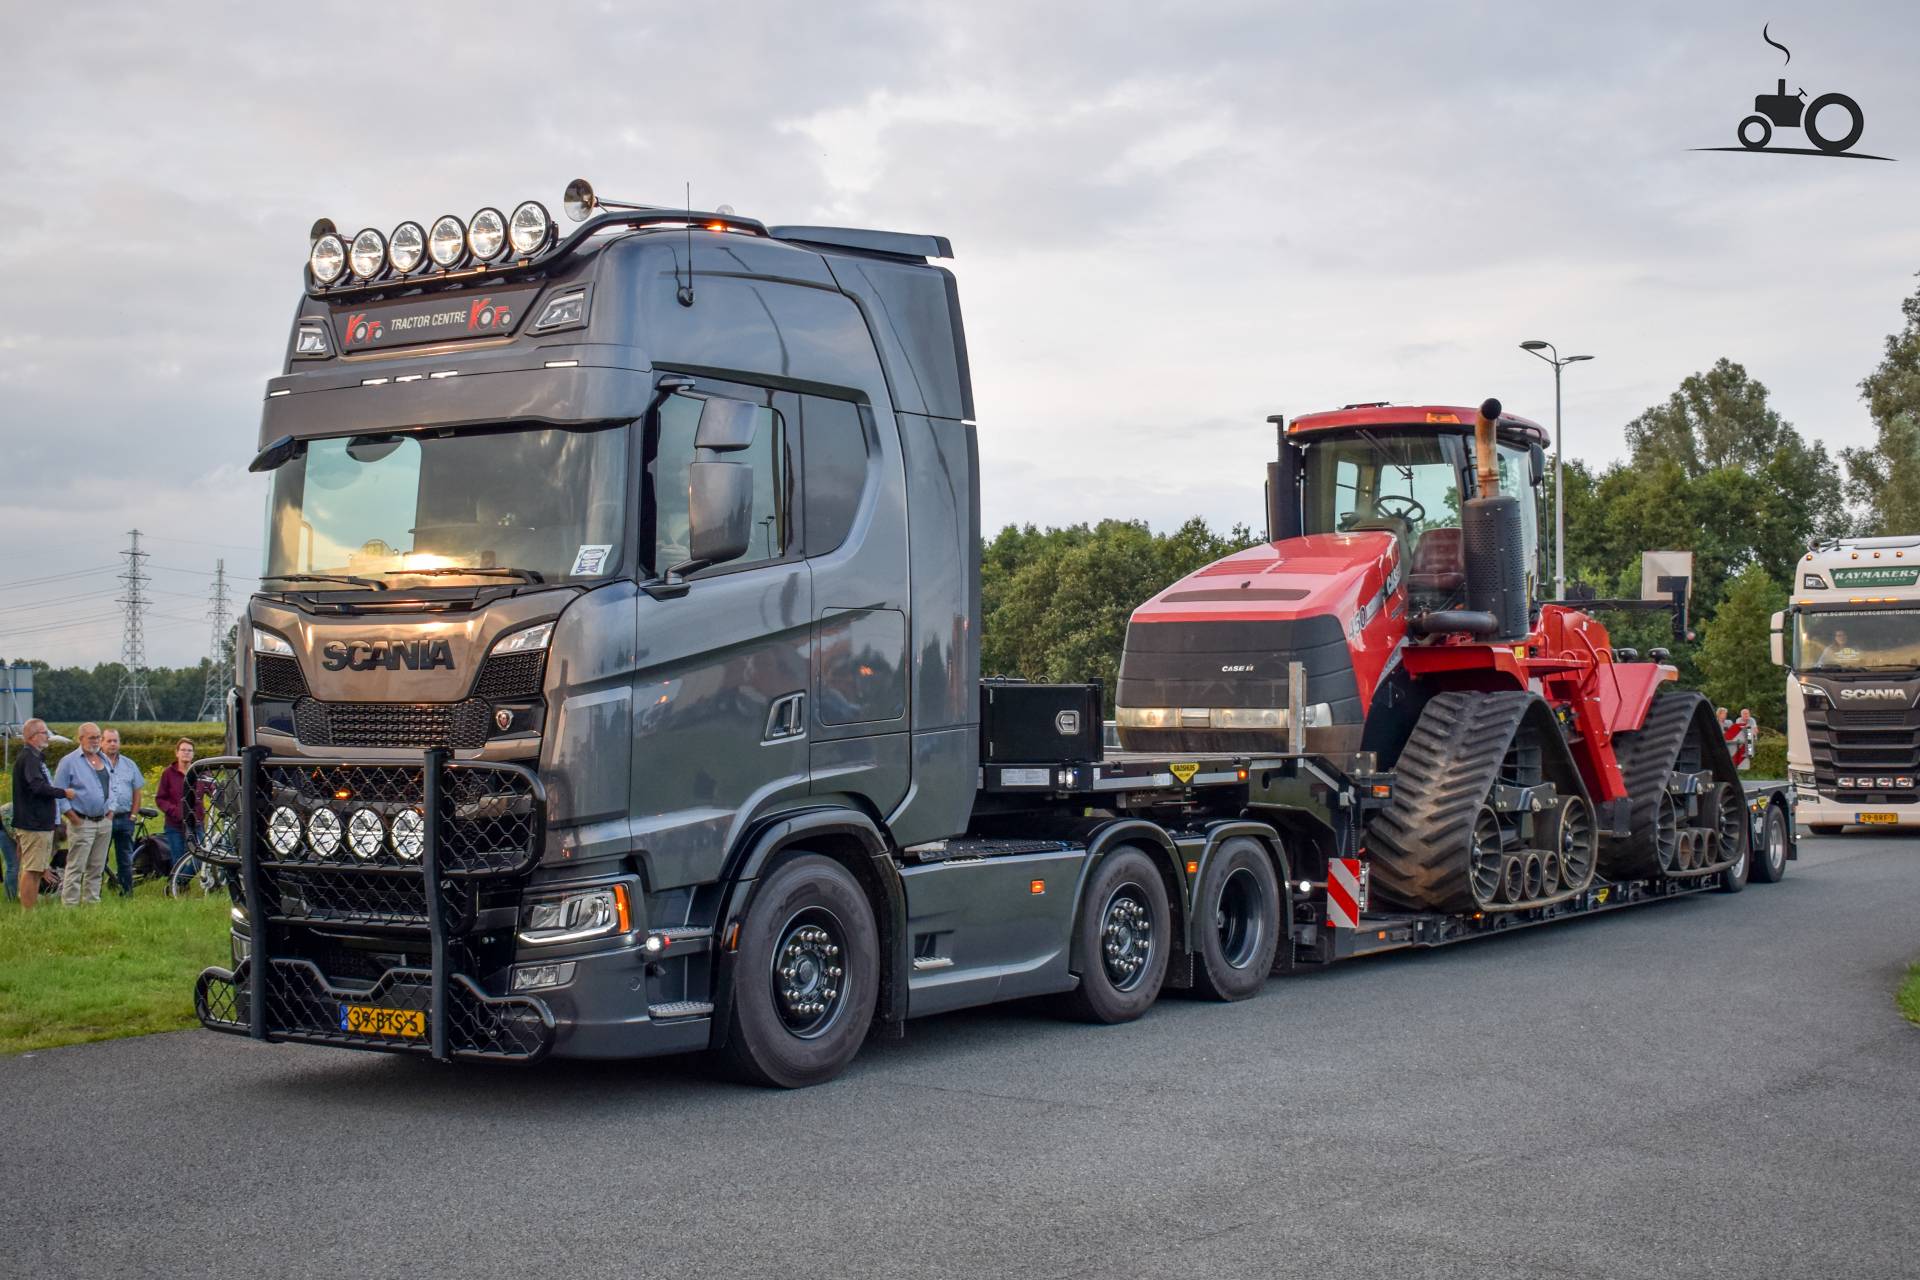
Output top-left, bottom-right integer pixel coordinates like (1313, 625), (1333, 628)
(647, 395), (795, 574)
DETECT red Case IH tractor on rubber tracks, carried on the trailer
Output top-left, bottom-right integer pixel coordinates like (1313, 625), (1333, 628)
(1117, 399), (1749, 913)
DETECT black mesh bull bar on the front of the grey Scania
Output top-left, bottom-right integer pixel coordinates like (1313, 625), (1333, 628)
(188, 748), (555, 1061)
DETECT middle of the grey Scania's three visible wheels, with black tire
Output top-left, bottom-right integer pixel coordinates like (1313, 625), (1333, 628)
(1066, 846), (1173, 1023)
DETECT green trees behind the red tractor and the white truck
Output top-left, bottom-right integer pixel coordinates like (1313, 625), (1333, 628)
(981, 272), (1920, 729)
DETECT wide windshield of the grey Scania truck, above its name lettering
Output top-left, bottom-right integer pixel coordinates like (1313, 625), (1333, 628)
(265, 424), (628, 591)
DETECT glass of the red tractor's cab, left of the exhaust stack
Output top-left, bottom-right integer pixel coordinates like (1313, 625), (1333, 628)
(1302, 432), (1466, 608)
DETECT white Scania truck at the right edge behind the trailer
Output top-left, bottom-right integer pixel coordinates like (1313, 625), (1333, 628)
(1772, 535), (1920, 835)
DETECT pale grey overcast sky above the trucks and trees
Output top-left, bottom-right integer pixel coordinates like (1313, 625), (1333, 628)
(0, 0), (1920, 664)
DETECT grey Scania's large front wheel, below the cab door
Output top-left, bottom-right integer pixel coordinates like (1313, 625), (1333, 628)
(720, 854), (879, 1088)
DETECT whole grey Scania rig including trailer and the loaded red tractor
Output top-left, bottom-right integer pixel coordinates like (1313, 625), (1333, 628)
(192, 182), (1793, 1086)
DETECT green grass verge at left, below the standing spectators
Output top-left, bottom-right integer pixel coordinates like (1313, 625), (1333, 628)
(0, 881), (228, 1054)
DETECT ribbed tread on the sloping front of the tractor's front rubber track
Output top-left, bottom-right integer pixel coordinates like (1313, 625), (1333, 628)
(1367, 689), (1534, 912)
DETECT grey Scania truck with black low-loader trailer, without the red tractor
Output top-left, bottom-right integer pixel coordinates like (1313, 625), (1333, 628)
(194, 182), (1781, 1086)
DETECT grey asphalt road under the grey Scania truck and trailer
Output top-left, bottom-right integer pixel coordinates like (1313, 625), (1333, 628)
(0, 837), (1920, 1280)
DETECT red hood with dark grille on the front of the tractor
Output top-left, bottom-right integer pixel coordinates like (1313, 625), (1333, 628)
(1116, 530), (1407, 752)
